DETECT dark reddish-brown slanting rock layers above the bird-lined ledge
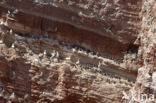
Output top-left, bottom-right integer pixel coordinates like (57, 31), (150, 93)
(0, 0), (141, 59)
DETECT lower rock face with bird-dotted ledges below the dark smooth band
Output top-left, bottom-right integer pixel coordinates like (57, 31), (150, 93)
(0, 26), (136, 103)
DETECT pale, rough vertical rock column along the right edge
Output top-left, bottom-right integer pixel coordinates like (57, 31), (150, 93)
(131, 0), (156, 101)
